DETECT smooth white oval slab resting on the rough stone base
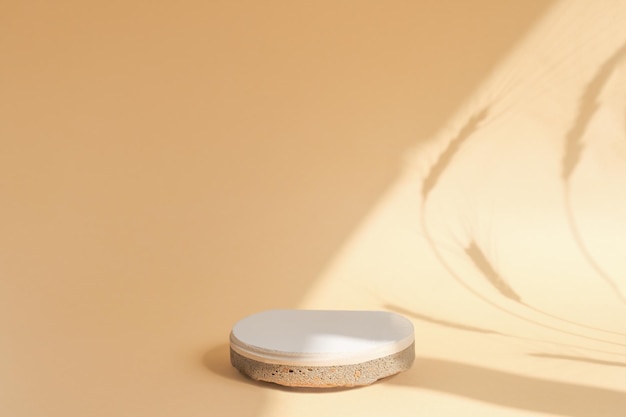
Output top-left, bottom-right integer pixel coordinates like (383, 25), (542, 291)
(230, 310), (415, 366)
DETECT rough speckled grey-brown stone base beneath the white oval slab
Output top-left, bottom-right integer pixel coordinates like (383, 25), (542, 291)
(230, 343), (415, 388)
